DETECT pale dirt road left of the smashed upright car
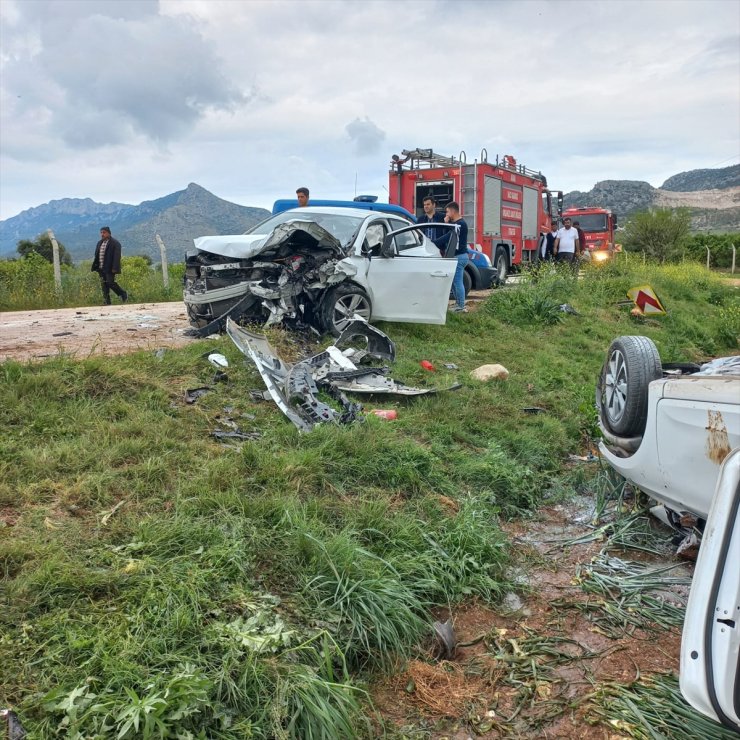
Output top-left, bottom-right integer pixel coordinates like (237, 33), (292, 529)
(0, 301), (193, 362)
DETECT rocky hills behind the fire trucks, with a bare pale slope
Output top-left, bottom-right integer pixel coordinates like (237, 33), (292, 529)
(564, 165), (740, 232)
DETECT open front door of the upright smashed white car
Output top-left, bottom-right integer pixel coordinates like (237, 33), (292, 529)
(366, 220), (457, 324)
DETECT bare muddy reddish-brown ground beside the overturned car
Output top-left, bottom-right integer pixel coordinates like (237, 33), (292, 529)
(370, 488), (693, 740)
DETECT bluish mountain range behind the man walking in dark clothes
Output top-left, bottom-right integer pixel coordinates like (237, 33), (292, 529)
(0, 183), (269, 261)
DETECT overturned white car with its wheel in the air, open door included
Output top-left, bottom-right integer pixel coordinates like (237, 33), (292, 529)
(596, 336), (740, 732)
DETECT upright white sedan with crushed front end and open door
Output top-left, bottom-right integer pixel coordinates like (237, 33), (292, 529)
(183, 207), (456, 336)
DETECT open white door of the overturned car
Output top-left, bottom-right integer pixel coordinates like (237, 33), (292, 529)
(680, 448), (740, 732)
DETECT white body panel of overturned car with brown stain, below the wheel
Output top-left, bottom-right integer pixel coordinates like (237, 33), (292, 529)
(599, 376), (740, 518)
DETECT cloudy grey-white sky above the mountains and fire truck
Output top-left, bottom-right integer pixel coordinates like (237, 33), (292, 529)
(0, 0), (740, 219)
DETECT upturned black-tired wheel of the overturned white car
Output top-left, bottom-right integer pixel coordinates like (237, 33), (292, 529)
(599, 336), (663, 437)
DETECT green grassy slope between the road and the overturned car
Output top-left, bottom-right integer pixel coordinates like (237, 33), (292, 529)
(0, 258), (740, 739)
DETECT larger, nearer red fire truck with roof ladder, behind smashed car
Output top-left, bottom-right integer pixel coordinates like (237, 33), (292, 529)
(388, 149), (563, 283)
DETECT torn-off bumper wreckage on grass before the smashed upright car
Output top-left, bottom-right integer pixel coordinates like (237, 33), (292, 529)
(226, 318), (460, 432)
